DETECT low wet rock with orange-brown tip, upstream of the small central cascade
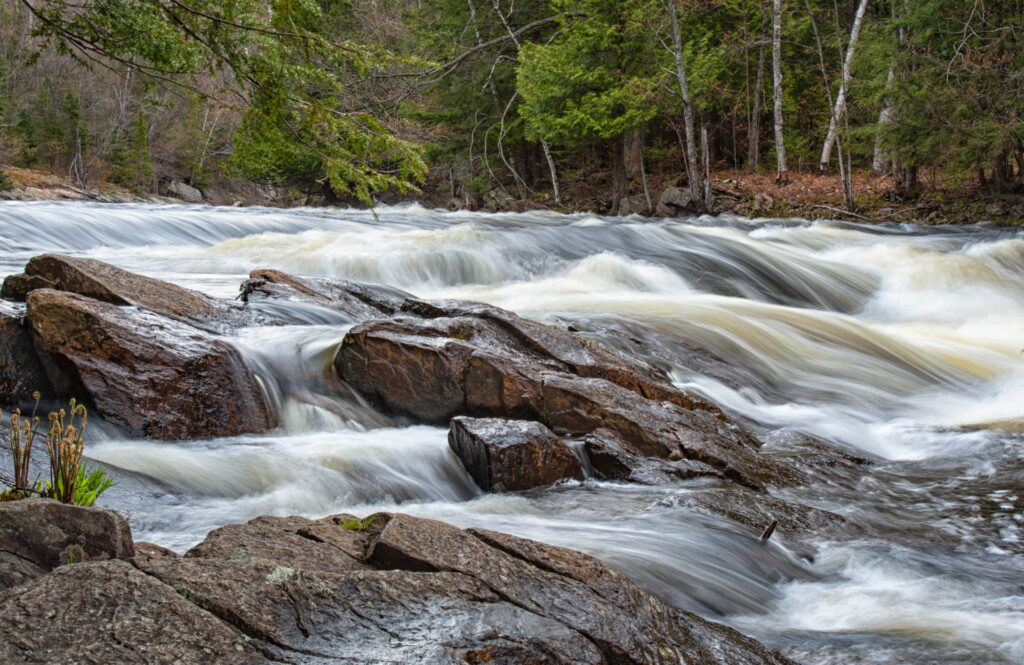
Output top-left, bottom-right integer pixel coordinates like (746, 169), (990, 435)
(241, 269), (412, 321)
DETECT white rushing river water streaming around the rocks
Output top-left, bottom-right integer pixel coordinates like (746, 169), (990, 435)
(0, 203), (1024, 664)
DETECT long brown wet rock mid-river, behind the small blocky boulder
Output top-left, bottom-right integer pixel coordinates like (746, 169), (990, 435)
(335, 301), (799, 488)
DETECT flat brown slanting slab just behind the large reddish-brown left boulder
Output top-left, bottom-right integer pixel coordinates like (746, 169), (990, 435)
(25, 254), (230, 324)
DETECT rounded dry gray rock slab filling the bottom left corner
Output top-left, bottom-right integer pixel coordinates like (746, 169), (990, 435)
(0, 562), (267, 665)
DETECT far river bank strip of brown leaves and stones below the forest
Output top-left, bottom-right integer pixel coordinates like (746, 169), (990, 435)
(0, 162), (1024, 225)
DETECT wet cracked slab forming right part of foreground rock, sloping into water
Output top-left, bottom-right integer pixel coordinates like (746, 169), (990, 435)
(367, 514), (787, 664)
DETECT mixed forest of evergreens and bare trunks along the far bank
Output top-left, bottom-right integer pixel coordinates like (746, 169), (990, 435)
(0, 0), (1024, 213)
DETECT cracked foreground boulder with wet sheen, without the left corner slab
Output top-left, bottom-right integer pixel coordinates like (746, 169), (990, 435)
(123, 513), (788, 665)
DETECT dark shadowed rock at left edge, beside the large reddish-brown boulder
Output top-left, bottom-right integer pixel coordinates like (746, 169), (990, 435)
(0, 301), (53, 406)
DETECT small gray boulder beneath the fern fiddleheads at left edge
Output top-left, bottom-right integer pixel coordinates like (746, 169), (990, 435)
(0, 499), (135, 590)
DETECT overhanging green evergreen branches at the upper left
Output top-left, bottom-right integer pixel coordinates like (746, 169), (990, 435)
(23, 0), (426, 203)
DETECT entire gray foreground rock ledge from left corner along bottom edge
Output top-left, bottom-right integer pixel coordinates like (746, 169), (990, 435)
(0, 506), (790, 665)
